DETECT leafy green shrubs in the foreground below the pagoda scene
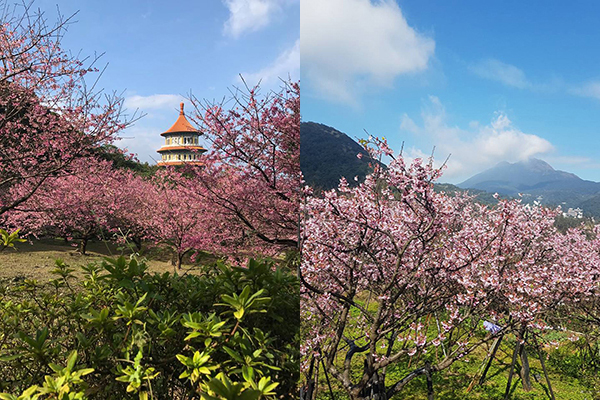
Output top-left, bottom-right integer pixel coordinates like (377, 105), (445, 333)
(0, 257), (299, 400)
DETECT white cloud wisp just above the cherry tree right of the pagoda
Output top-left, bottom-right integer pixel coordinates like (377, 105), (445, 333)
(242, 40), (300, 88)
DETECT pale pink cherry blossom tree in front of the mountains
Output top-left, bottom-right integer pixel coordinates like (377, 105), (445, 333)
(300, 141), (600, 399)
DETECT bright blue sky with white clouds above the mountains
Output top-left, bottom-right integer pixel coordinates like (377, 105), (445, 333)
(300, 0), (600, 183)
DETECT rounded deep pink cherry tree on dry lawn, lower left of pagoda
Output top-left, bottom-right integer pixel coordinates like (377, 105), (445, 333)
(7, 159), (142, 254)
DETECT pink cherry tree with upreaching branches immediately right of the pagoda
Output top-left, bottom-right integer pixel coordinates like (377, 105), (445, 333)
(180, 82), (301, 254)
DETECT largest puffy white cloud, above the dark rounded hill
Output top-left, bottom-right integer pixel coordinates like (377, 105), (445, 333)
(300, 0), (435, 104)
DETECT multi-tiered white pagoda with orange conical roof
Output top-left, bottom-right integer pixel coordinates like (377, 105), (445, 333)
(157, 103), (206, 166)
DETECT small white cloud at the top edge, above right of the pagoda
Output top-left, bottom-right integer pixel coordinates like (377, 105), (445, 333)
(223, 0), (293, 38)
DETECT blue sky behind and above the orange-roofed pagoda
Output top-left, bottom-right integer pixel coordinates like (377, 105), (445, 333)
(34, 0), (300, 162)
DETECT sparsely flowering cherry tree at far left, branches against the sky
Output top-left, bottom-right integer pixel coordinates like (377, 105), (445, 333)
(0, 1), (131, 215)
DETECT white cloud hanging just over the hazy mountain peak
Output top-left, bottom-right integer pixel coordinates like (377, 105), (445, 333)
(400, 96), (554, 182)
